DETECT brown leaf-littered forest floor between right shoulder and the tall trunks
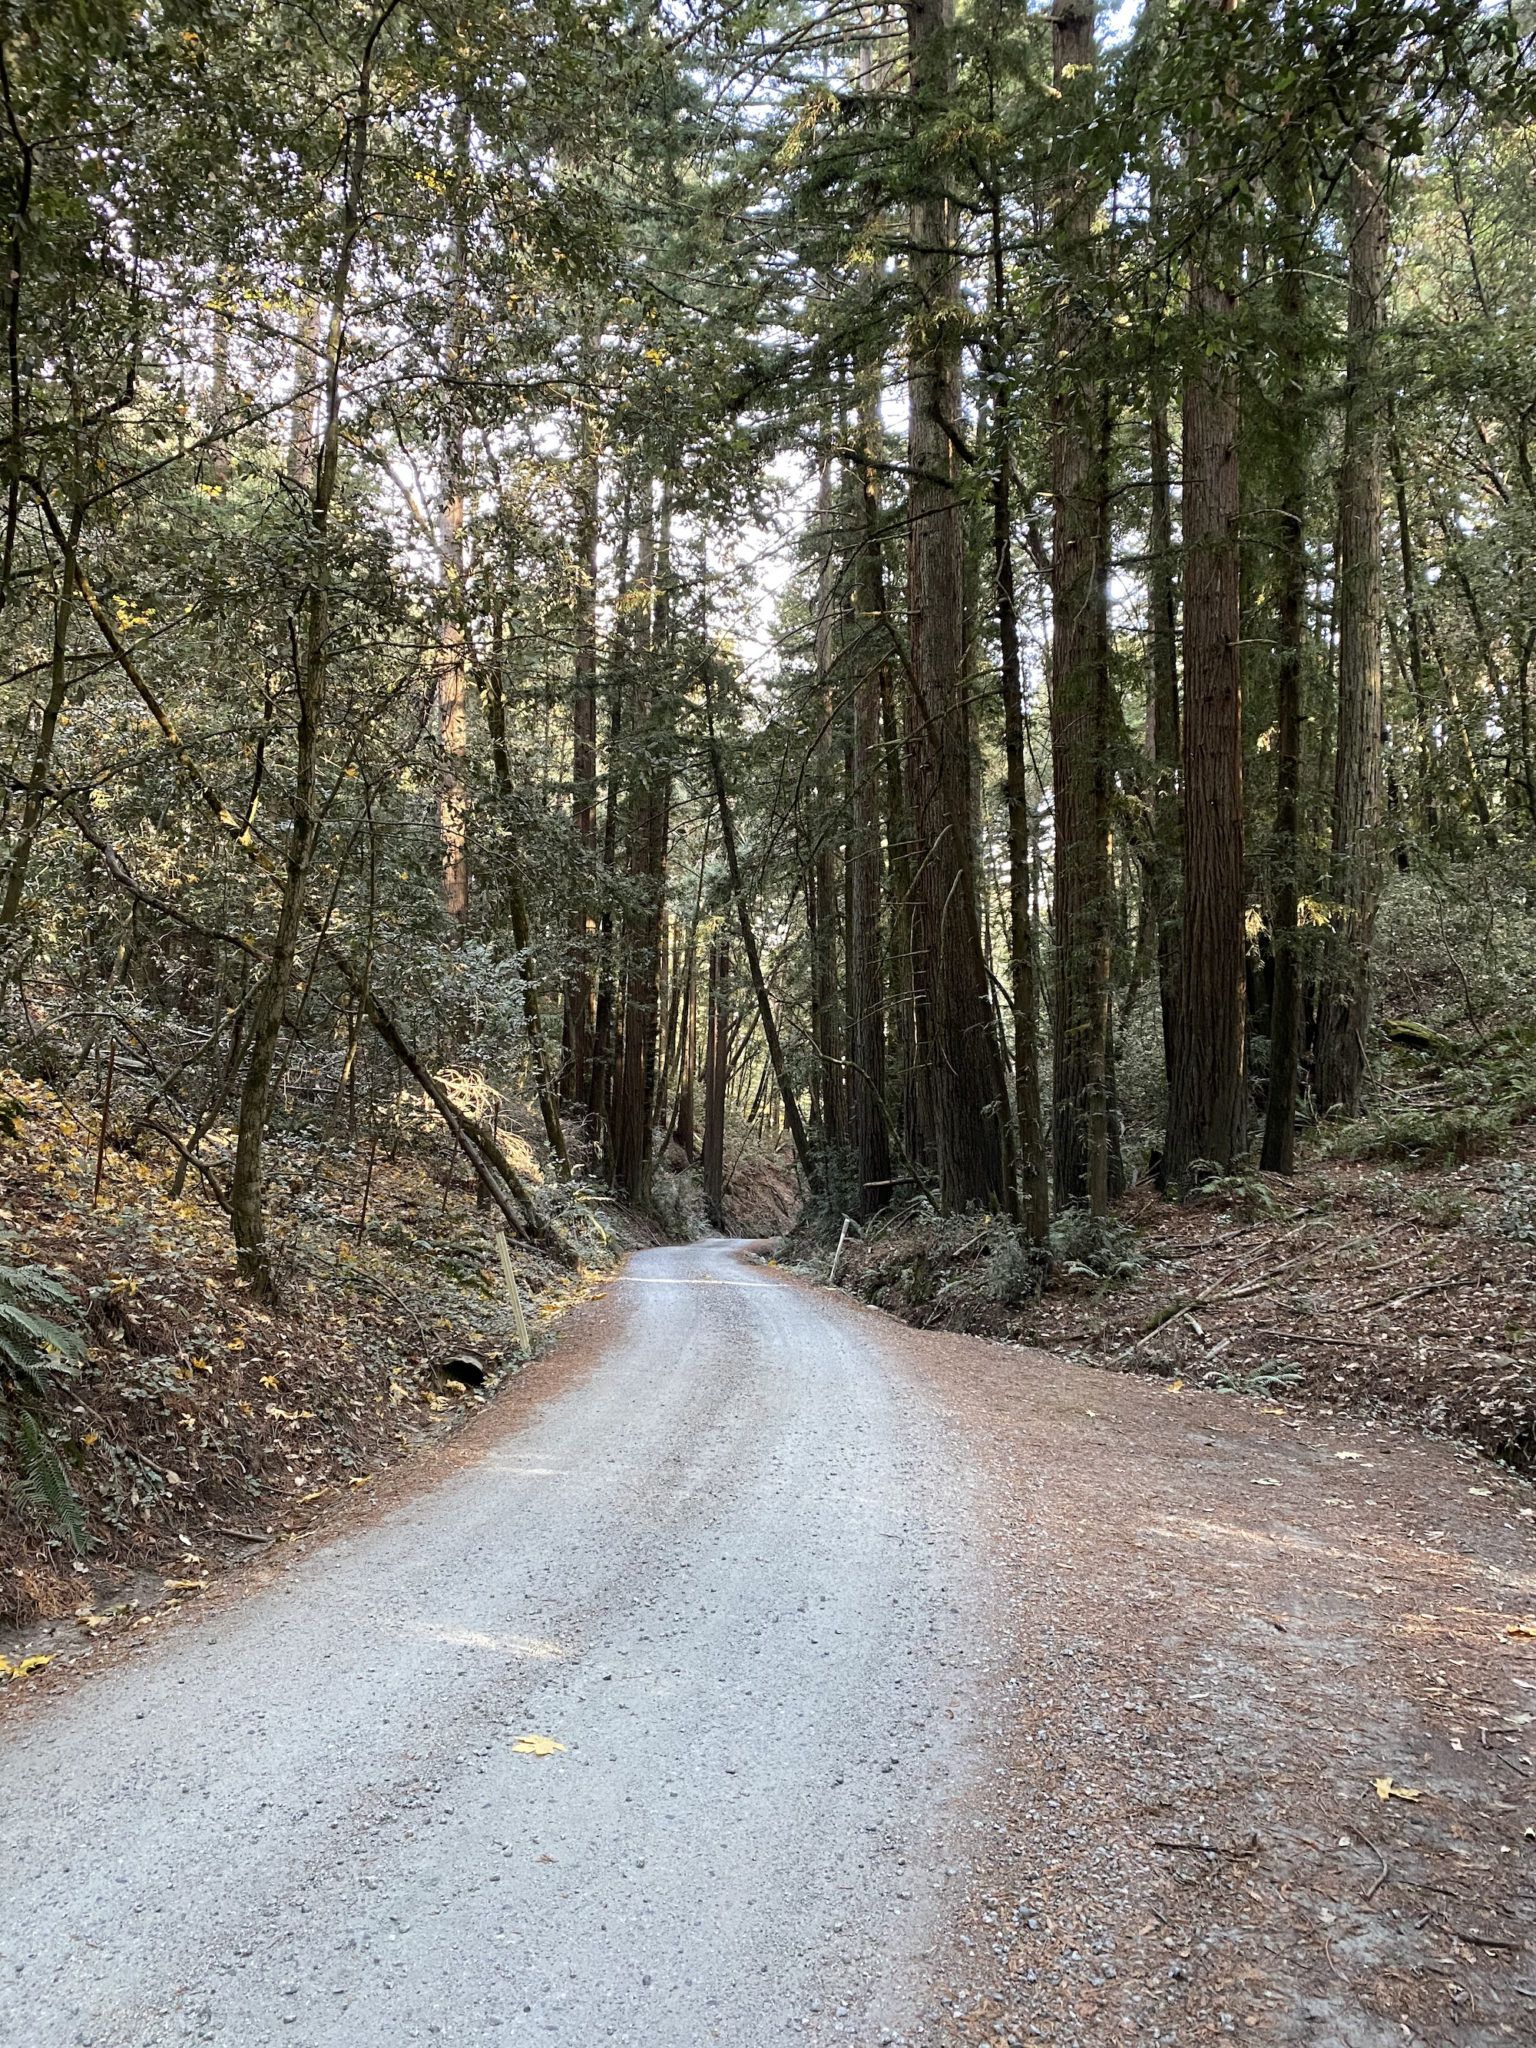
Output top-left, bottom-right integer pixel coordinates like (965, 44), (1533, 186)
(798, 1126), (1536, 1470)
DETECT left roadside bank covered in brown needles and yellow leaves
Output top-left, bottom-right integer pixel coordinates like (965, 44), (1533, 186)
(0, 1073), (616, 1638)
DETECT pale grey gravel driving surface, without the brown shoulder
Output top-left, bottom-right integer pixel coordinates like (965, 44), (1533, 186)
(0, 1243), (999, 2048)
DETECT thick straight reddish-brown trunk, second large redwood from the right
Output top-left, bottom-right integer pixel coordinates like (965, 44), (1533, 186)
(1163, 0), (1247, 1188)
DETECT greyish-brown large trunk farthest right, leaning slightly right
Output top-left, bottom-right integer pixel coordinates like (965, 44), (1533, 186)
(1313, 133), (1389, 1116)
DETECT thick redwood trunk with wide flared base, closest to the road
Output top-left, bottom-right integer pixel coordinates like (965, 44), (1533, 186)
(907, 0), (1012, 1208)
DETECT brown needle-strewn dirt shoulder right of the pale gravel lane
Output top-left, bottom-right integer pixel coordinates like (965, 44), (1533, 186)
(847, 1294), (1536, 2048)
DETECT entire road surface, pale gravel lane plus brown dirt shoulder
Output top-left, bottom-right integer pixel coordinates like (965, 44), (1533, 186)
(0, 1245), (1536, 2048)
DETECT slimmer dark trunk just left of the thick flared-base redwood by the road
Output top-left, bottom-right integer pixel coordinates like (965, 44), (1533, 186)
(848, 362), (891, 1217)
